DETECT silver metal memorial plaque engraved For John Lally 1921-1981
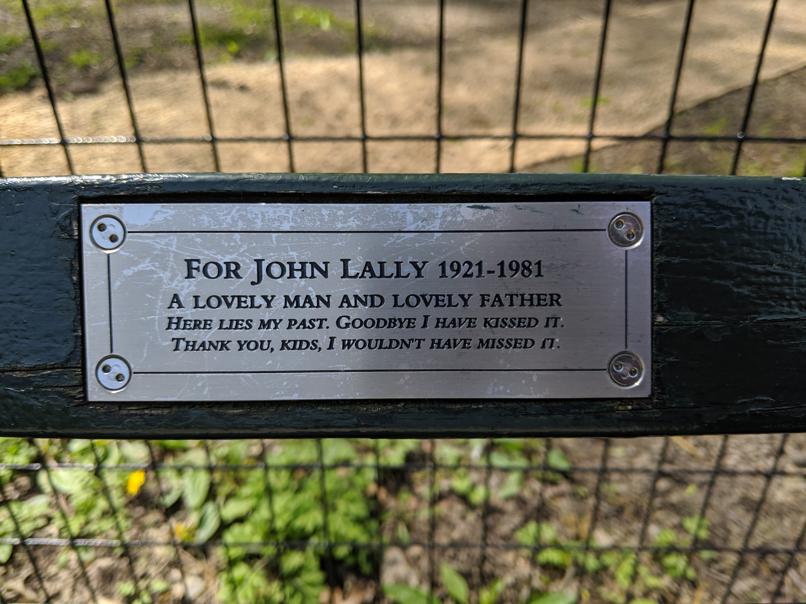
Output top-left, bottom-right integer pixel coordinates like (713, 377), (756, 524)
(81, 201), (652, 401)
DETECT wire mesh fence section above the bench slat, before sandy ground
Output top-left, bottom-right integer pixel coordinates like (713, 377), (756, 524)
(0, 0), (806, 176)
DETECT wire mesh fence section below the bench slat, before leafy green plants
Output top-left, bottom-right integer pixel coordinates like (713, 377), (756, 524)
(0, 435), (806, 602)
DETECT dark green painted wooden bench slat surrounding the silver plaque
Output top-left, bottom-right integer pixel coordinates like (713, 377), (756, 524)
(0, 174), (806, 437)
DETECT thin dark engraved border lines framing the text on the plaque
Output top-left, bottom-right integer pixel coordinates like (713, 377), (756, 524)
(101, 228), (629, 376)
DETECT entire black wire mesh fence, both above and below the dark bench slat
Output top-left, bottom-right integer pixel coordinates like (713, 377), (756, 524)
(0, 0), (806, 604)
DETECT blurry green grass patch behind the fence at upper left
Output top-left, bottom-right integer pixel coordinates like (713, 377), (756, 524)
(0, 0), (370, 95)
